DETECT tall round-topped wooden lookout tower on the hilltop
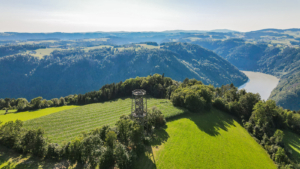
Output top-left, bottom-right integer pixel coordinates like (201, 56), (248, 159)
(131, 89), (147, 126)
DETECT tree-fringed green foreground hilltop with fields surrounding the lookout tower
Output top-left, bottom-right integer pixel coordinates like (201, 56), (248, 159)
(0, 74), (300, 169)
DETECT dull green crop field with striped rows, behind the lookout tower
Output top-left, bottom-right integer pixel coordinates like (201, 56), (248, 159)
(24, 98), (185, 144)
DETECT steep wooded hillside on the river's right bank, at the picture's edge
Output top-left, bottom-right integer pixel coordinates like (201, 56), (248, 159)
(261, 48), (300, 110)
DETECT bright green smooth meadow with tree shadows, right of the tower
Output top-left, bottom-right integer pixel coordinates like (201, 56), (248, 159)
(136, 109), (276, 169)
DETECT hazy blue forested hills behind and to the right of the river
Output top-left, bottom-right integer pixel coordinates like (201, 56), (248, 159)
(193, 39), (300, 110)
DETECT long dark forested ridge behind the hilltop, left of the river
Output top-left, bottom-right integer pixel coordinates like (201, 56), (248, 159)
(0, 43), (247, 99)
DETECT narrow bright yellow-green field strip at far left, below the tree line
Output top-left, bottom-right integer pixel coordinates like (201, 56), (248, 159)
(0, 106), (78, 123)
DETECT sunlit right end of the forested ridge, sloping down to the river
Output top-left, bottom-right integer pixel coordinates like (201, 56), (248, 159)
(161, 42), (247, 86)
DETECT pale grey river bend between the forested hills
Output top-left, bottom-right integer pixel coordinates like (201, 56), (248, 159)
(239, 71), (279, 100)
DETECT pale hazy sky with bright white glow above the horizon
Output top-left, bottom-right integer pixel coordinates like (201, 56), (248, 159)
(0, 0), (300, 32)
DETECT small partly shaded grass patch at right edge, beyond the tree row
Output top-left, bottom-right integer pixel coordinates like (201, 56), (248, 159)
(283, 130), (300, 163)
